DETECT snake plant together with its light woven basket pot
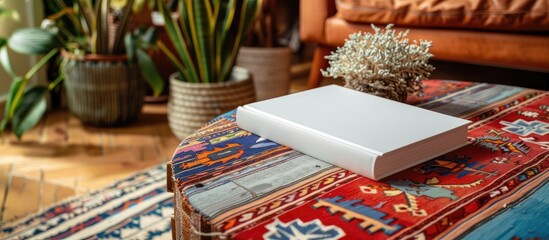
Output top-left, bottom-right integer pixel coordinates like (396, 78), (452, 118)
(157, 0), (261, 139)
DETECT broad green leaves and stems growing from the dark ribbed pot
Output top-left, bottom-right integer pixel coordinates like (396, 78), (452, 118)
(0, 0), (164, 138)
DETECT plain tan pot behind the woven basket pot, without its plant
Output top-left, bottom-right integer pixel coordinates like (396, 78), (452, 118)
(236, 47), (292, 100)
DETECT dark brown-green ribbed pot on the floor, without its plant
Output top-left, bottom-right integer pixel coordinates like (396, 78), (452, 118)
(63, 53), (145, 127)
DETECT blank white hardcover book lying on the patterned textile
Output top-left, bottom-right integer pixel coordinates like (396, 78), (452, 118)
(236, 85), (470, 180)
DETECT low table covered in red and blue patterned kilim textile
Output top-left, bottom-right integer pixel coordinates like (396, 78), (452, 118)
(168, 80), (549, 239)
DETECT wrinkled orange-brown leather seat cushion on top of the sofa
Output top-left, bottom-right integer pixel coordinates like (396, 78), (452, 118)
(336, 0), (549, 32)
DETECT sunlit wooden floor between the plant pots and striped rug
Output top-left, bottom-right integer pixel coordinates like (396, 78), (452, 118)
(0, 104), (179, 221)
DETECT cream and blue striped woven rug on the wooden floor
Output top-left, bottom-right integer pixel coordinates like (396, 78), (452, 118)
(0, 165), (173, 239)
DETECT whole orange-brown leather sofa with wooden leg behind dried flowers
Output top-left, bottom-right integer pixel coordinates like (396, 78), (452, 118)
(300, 0), (549, 88)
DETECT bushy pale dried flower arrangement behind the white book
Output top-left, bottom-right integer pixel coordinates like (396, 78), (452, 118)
(321, 24), (434, 102)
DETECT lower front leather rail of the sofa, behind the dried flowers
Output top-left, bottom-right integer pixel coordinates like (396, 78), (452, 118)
(325, 16), (549, 72)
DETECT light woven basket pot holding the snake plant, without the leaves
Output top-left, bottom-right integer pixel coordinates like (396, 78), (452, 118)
(168, 67), (256, 140)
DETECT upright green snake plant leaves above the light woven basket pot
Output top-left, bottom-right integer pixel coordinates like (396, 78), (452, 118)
(156, 0), (261, 83)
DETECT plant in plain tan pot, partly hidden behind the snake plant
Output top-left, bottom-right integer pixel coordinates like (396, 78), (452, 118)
(236, 0), (292, 100)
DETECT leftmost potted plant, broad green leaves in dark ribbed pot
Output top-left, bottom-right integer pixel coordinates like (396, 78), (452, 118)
(0, 0), (163, 137)
